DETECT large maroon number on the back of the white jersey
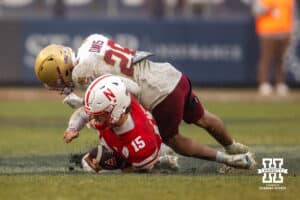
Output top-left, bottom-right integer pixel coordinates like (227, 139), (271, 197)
(104, 40), (135, 76)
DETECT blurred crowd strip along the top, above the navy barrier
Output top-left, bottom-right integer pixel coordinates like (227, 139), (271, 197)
(0, 0), (264, 18)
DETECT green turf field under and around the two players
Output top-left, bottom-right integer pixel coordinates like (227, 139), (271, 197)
(0, 92), (300, 200)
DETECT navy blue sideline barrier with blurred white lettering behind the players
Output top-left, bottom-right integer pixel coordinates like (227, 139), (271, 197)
(0, 18), (300, 86)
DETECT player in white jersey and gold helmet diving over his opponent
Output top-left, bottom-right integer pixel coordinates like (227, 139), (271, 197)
(35, 34), (256, 168)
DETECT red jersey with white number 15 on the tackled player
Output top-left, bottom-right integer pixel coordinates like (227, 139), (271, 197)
(96, 97), (162, 169)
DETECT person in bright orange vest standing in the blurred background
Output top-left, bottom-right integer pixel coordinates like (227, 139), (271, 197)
(251, 0), (295, 96)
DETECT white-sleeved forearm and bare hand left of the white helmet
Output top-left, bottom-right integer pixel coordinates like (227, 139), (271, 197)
(64, 107), (89, 143)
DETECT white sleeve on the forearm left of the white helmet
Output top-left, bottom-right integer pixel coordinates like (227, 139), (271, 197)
(67, 107), (89, 131)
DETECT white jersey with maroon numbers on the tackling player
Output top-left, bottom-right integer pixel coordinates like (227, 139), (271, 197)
(72, 34), (182, 110)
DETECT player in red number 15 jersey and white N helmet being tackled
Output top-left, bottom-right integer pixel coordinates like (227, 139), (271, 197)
(65, 74), (162, 171)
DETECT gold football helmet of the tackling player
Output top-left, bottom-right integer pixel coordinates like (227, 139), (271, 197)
(34, 44), (75, 90)
